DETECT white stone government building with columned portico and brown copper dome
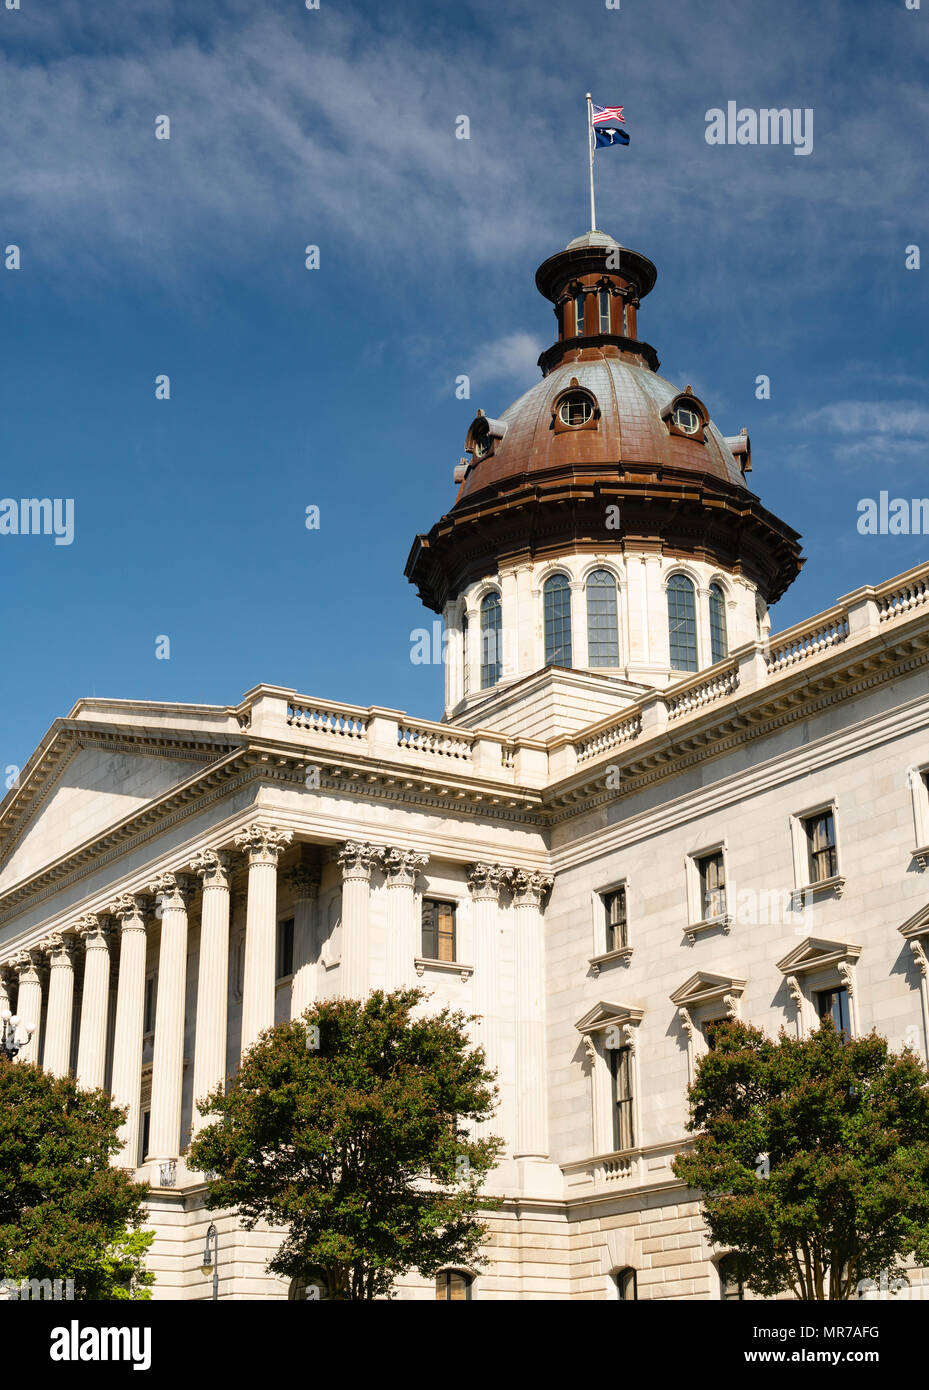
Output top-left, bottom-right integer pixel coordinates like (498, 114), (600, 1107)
(0, 222), (929, 1300)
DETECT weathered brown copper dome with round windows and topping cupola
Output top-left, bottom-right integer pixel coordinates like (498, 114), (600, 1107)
(406, 231), (802, 613)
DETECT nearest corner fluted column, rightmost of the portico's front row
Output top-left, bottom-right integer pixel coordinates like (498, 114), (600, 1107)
(235, 826), (293, 1052)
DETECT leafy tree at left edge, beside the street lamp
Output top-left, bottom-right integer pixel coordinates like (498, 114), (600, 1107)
(0, 1058), (153, 1300)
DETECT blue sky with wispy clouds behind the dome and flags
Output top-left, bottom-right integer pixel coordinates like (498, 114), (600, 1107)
(0, 0), (929, 766)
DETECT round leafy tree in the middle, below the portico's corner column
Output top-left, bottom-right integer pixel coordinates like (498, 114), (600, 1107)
(188, 990), (502, 1300)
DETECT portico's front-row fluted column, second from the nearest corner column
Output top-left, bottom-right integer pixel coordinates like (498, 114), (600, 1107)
(191, 849), (232, 1134)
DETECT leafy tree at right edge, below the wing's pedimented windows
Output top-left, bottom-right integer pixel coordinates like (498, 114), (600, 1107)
(673, 1019), (929, 1300)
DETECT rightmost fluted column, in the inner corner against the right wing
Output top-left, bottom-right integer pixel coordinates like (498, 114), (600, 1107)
(509, 869), (552, 1158)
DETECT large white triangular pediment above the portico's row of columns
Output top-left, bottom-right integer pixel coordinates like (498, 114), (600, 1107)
(0, 727), (236, 892)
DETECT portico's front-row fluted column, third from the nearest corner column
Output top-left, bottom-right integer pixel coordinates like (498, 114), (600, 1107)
(146, 873), (195, 1163)
